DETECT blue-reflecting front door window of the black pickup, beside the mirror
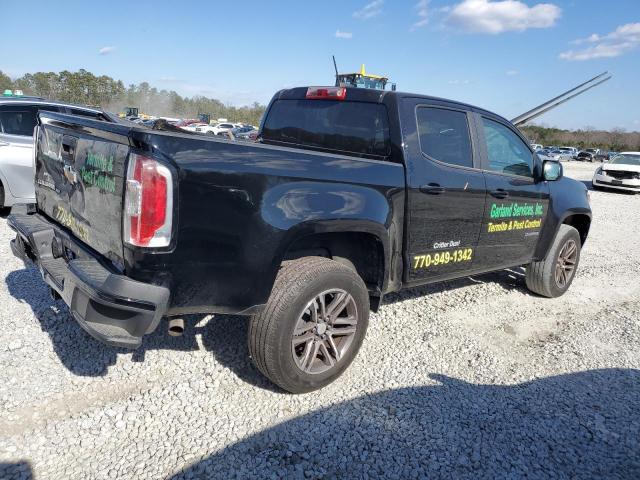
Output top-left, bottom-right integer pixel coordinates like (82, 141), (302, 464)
(482, 117), (533, 177)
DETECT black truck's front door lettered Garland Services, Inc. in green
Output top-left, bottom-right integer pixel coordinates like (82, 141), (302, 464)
(475, 115), (549, 270)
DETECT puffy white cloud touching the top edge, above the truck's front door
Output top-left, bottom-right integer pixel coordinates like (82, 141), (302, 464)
(445, 0), (562, 34)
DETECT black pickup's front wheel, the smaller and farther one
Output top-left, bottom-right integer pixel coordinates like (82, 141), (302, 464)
(525, 225), (581, 298)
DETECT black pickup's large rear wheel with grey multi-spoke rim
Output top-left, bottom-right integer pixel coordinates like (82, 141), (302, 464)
(248, 257), (369, 393)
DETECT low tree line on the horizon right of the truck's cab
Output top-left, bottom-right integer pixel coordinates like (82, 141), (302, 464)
(520, 125), (640, 152)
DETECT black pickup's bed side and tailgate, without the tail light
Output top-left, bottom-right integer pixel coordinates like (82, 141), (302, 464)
(36, 112), (405, 315)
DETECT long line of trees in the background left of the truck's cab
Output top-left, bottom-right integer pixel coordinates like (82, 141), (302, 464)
(0, 69), (265, 125)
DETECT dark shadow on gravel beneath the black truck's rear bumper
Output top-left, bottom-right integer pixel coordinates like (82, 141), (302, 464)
(0, 267), (280, 390)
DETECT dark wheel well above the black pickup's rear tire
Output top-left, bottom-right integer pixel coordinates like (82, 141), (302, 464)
(284, 232), (384, 296)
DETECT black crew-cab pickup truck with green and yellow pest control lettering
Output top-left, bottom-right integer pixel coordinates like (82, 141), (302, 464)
(9, 87), (591, 392)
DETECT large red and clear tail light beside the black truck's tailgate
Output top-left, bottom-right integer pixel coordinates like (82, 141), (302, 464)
(123, 154), (173, 247)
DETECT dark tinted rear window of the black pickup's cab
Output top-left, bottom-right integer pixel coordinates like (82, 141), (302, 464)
(262, 100), (390, 158)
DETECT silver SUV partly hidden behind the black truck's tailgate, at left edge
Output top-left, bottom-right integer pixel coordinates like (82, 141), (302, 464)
(0, 96), (114, 208)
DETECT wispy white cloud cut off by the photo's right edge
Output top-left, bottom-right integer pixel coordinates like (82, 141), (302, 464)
(560, 22), (640, 61)
